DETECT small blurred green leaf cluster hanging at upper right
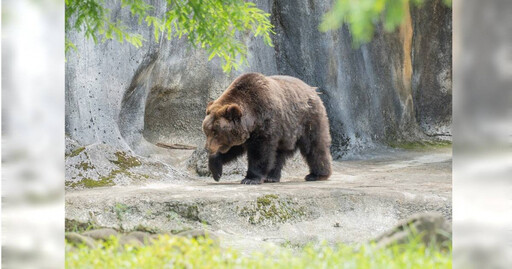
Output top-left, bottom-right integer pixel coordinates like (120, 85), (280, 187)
(319, 0), (451, 47)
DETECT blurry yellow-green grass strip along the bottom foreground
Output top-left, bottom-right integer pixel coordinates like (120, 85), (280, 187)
(66, 235), (452, 269)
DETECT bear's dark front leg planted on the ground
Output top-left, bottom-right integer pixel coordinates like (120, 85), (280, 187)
(241, 142), (276, 184)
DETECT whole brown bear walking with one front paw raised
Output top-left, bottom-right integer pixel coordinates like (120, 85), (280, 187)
(203, 73), (331, 184)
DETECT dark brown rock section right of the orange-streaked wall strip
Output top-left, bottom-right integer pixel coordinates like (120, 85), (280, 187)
(411, 0), (452, 139)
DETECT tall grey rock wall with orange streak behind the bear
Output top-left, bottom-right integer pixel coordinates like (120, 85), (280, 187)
(66, 0), (451, 158)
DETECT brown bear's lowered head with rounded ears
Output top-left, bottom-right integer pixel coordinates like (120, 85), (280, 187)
(203, 102), (250, 154)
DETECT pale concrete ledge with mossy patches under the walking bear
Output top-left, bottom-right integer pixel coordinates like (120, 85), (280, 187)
(66, 148), (452, 251)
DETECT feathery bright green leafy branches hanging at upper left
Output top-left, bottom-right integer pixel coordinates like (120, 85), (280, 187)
(66, 0), (274, 72)
